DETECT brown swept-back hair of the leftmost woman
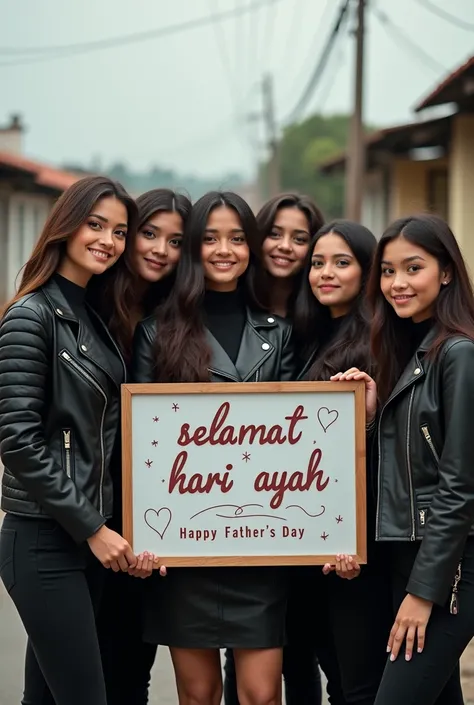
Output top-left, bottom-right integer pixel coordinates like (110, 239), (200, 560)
(3, 176), (137, 311)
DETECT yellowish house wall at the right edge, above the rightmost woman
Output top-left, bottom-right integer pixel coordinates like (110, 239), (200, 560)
(449, 115), (474, 276)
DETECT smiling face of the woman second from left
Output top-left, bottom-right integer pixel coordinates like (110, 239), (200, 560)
(133, 211), (183, 283)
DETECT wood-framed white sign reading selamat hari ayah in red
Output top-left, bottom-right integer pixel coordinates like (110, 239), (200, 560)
(122, 382), (366, 566)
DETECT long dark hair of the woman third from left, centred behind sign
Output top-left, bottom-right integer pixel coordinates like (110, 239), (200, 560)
(152, 191), (264, 382)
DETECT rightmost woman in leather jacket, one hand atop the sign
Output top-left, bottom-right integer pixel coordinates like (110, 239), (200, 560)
(334, 215), (474, 705)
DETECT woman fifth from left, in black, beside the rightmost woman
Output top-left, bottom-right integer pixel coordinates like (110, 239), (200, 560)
(295, 220), (392, 705)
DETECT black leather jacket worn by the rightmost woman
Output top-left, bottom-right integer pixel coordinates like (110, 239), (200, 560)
(376, 330), (474, 605)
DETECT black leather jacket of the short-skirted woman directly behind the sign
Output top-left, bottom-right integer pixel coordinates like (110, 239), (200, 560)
(132, 308), (295, 382)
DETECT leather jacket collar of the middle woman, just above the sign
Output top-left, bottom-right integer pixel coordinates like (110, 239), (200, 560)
(206, 307), (278, 382)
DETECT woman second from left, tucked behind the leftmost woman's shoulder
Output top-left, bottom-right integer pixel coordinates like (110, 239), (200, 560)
(89, 189), (191, 705)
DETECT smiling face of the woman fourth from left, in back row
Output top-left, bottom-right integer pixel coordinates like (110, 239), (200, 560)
(262, 207), (310, 278)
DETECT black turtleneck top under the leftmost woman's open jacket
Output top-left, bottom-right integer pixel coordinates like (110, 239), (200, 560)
(54, 273), (124, 384)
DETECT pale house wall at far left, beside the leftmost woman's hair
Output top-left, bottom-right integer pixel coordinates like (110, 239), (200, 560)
(0, 188), (53, 301)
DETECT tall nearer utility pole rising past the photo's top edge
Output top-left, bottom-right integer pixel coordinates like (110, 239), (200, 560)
(346, 0), (367, 221)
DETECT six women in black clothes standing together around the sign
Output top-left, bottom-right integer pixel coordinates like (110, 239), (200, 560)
(0, 177), (474, 705)
